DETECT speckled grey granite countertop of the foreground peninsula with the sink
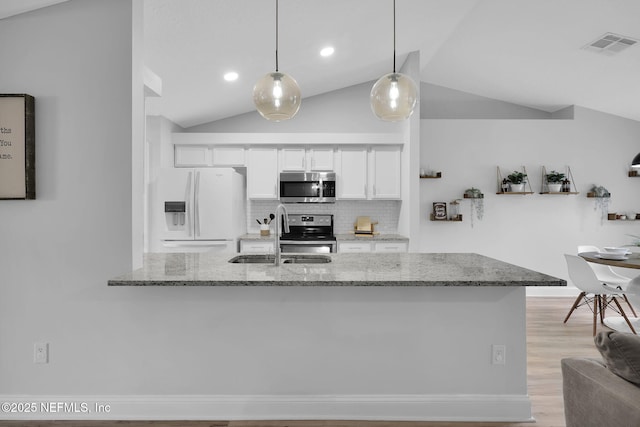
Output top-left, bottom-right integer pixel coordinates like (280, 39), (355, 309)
(109, 253), (567, 286)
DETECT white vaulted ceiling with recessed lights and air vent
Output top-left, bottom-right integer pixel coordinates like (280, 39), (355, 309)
(0, 0), (640, 127)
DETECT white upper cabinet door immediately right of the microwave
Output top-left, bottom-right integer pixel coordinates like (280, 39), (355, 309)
(336, 147), (367, 199)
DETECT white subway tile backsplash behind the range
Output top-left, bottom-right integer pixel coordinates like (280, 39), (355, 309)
(247, 200), (402, 234)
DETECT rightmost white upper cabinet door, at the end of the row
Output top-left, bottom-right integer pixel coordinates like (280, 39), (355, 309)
(369, 147), (402, 199)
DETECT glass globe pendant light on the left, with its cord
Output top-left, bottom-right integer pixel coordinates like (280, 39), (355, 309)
(253, 0), (302, 122)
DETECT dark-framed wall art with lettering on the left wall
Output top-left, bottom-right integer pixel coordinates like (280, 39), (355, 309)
(0, 94), (36, 200)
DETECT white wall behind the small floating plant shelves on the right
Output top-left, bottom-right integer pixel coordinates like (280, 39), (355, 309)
(420, 107), (640, 294)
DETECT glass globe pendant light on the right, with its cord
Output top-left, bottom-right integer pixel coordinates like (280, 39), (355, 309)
(370, 0), (418, 122)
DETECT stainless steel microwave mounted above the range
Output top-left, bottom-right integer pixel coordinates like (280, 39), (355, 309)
(280, 172), (336, 203)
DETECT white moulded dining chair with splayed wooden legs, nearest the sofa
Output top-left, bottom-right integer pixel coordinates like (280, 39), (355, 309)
(564, 254), (636, 336)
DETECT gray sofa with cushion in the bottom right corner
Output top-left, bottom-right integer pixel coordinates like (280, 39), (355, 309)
(561, 331), (640, 427)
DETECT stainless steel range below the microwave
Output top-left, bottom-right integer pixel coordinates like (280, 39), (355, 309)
(280, 214), (336, 253)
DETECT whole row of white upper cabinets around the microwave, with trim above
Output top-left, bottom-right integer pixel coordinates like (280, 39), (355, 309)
(172, 133), (403, 200)
